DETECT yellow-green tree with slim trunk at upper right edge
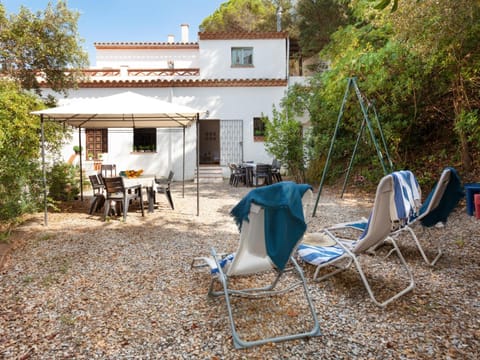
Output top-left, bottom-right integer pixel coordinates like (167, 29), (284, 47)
(392, 0), (480, 171)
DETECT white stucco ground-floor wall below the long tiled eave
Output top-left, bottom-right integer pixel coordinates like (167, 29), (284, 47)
(46, 87), (285, 180)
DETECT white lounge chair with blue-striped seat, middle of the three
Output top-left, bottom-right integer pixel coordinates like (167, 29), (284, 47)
(298, 174), (415, 307)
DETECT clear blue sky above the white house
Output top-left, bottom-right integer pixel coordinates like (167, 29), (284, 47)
(0, 0), (227, 66)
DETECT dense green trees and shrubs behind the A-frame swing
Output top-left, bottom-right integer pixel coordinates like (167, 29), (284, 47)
(272, 0), (480, 186)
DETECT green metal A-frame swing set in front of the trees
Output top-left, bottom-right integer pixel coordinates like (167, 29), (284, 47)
(312, 77), (393, 217)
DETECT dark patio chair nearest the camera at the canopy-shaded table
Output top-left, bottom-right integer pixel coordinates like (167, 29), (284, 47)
(103, 176), (145, 222)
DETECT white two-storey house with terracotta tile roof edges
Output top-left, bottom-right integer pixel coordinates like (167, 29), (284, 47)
(41, 25), (304, 179)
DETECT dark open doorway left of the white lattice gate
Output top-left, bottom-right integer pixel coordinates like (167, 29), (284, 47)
(200, 120), (220, 165)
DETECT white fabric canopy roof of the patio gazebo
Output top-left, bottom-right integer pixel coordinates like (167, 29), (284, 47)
(33, 91), (199, 129)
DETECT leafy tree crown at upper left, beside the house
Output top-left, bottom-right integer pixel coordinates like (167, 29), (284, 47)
(0, 0), (88, 92)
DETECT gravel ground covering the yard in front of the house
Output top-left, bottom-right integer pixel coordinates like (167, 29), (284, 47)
(0, 183), (480, 359)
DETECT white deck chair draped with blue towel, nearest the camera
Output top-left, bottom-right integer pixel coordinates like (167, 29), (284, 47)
(192, 182), (320, 349)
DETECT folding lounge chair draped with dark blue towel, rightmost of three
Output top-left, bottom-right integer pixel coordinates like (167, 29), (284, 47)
(392, 167), (465, 266)
